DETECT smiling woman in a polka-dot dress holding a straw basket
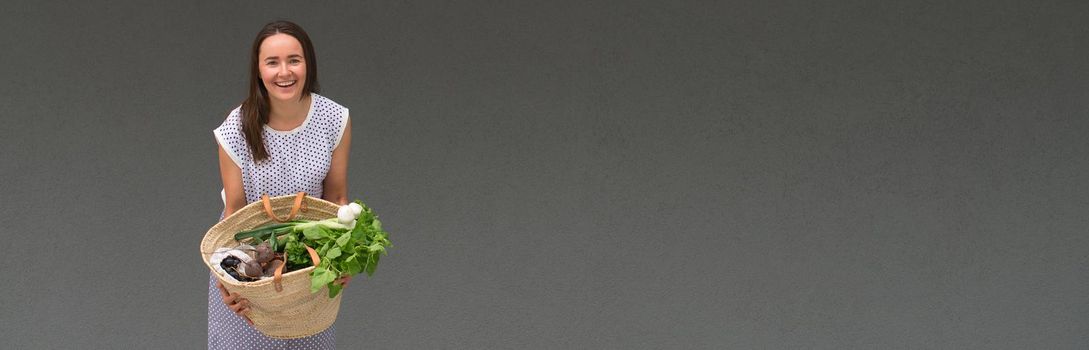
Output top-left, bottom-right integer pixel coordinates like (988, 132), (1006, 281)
(208, 21), (352, 349)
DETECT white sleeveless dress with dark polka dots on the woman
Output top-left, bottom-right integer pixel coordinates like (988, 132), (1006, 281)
(208, 94), (348, 349)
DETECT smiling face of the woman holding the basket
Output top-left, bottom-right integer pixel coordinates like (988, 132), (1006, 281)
(257, 33), (306, 101)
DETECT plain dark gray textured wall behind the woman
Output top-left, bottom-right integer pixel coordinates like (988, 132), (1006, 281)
(0, 1), (1089, 349)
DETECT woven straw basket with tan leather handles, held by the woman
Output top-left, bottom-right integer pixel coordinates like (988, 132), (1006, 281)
(200, 193), (344, 339)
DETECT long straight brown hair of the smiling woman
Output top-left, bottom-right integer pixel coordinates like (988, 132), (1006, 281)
(242, 21), (320, 162)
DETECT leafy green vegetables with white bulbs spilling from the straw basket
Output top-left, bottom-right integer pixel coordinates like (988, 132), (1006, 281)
(234, 200), (393, 298)
